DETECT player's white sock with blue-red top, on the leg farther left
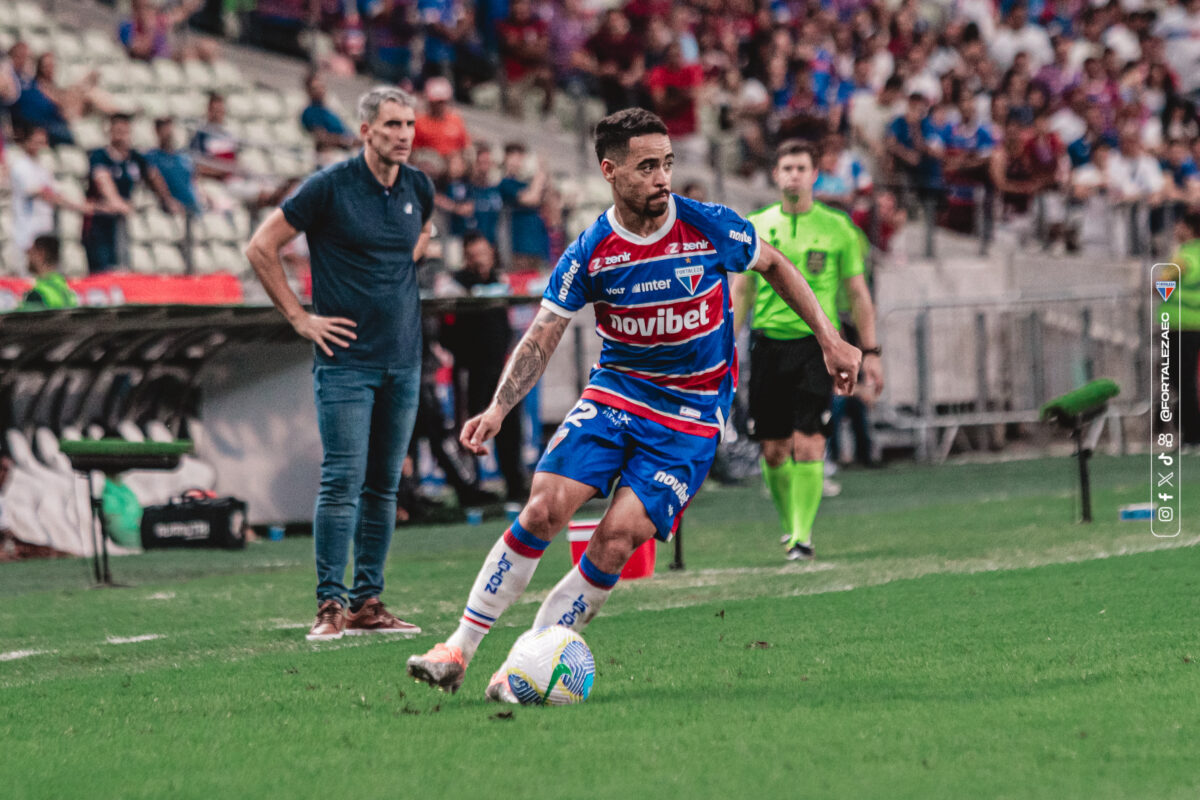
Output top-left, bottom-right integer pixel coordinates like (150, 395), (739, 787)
(446, 521), (550, 663)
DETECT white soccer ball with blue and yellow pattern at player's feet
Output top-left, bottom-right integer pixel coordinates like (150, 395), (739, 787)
(505, 625), (596, 705)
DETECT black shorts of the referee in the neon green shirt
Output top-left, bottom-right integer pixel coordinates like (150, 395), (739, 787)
(749, 331), (833, 441)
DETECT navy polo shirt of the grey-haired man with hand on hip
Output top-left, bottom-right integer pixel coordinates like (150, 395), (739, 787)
(282, 154), (433, 369)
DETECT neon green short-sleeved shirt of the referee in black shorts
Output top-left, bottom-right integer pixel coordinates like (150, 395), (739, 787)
(746, 203), (864, 339)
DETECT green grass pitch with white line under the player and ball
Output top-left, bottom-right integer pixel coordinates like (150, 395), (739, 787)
(0, 456), (1200, 800)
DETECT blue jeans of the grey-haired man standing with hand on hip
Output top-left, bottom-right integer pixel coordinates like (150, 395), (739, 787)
(312, 365), (421, 607)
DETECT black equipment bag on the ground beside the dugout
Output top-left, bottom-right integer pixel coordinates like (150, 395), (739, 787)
(142, 491), (246, 551)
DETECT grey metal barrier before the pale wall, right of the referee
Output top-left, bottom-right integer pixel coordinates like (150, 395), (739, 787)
(876, 289), (1150, 461)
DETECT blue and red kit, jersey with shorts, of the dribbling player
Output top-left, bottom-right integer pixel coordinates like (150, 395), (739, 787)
(538, 196), (760, 539)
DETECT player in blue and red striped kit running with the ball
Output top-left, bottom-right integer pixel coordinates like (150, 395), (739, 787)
(408, 108), (860, 702)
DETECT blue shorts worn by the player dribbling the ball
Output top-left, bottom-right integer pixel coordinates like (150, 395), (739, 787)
(538, 401), (718, 542)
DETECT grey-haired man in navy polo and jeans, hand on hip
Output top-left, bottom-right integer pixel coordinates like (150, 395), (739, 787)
(246, 86), (433, 640)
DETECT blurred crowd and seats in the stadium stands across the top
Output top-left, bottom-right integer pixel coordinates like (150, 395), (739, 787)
(0, 0), (1200, 281)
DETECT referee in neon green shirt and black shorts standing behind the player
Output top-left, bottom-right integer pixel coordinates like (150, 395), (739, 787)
(733, 140), (883, 560)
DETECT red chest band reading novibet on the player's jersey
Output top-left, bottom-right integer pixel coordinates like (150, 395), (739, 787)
(596, 283), (724, 345)
